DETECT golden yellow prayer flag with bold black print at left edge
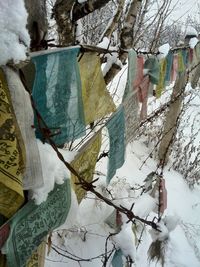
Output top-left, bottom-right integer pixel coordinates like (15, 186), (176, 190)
(0, 69), (25, 218)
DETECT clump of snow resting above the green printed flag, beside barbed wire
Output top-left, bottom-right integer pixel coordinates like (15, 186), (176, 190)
(30, 140), (76, 205)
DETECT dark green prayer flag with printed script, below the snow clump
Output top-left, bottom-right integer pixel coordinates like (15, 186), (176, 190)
(5, 179), (71, 267)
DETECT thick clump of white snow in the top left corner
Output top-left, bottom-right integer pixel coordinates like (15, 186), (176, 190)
(0, 0), (30, 65)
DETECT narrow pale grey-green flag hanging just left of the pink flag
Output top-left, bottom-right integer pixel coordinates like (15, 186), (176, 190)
(123, 49), (137, 101)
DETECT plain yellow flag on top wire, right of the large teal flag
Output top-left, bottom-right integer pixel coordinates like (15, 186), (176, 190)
(79, 53), (116, 124)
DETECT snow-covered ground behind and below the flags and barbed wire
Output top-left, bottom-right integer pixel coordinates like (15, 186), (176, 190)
(45, 68), (200, 267)
